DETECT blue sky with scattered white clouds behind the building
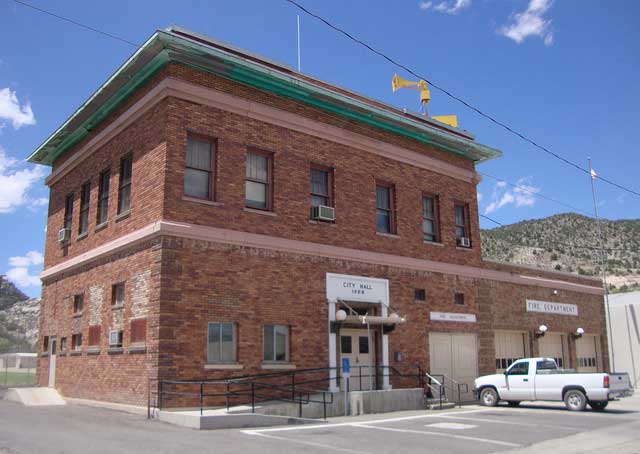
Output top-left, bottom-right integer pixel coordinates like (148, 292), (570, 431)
(0, 0), (640, 295)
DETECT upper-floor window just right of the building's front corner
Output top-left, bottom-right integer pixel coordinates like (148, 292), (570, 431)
(184, 137), (215, 200)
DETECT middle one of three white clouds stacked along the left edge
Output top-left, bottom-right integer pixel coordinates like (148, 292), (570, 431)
(0, 146), (47, 214)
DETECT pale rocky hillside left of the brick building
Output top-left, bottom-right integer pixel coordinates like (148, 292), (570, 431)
(0, 276), (40, 353)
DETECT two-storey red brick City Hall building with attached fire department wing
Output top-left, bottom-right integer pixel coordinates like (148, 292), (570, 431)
(30, 27), (608, 403)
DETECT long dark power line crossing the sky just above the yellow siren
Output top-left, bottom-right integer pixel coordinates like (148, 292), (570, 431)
(285, 0), (640, 196)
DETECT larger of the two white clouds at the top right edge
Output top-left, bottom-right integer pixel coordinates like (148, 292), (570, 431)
(498, 0), (553, 46)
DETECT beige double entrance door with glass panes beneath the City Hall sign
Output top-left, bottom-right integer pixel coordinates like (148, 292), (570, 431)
(340, 329), (376, 391)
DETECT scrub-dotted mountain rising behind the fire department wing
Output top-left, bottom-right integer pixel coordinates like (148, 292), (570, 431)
(481, 213), (640, 292)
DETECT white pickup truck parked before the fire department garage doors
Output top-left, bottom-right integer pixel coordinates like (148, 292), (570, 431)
(474, 358), (633, 411)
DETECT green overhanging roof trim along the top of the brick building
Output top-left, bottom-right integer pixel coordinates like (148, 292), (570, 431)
(28, 27), (502, 165)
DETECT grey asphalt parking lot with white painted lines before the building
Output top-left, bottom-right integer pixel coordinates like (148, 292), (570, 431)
(0, 398), (640, 454)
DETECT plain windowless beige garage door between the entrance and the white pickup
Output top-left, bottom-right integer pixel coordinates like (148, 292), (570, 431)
(429, 333), (478, 401)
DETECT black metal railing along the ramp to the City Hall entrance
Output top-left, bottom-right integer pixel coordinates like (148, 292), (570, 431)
(147, 365), (425, 419)
